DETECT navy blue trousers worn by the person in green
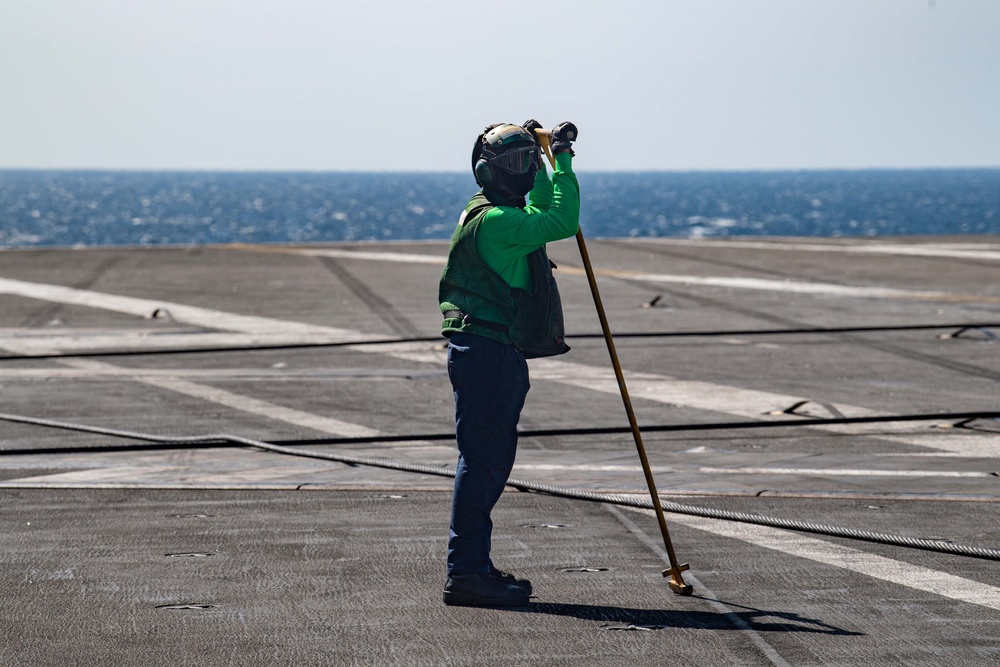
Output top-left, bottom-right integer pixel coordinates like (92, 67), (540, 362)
(448, 334), (529, 576)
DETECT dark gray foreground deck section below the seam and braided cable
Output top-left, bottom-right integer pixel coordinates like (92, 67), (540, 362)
(4, 489), (996, 665)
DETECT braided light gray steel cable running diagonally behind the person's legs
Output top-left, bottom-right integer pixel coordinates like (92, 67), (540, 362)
(0, 413), (1000, 561)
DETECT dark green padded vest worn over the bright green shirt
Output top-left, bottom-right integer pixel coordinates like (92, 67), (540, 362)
(438, 192), (569, 359)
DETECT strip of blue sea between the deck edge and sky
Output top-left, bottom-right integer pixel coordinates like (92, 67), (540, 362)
(0, 168), (1000, 248)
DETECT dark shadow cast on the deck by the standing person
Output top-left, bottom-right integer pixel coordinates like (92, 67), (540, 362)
(509, 596), (864, 637)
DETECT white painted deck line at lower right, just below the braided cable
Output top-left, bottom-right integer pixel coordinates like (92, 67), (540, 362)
(623, 508), (1000, 611)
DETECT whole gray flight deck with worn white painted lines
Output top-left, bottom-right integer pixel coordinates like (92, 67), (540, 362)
(0, 237), (1000, 665)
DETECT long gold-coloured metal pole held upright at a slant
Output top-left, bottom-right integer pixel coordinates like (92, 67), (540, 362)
(536, 130), (694, 595)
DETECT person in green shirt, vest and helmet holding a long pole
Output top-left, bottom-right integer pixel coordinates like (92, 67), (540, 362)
(438, 120), (580, 607)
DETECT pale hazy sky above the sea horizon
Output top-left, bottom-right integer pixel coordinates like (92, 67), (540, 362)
(0, 0), (1000, 171)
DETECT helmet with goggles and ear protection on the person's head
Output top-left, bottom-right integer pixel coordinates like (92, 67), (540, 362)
(472, 123), (539, 197)
